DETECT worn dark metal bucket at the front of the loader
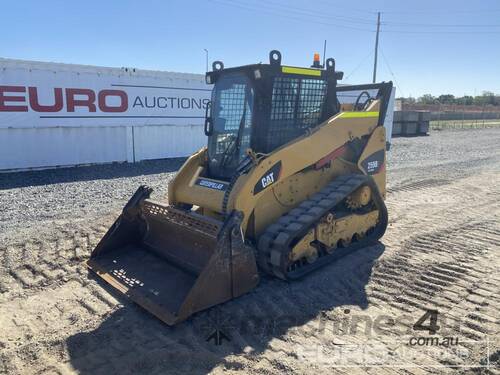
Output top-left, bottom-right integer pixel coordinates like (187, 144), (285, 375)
(87, 186), (258, 325)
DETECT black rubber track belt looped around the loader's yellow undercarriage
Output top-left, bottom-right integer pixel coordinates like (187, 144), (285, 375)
(258, 174), (388, 280)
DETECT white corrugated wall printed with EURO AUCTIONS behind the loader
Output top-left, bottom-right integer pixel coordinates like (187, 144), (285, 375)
(0, 59), (211, 170)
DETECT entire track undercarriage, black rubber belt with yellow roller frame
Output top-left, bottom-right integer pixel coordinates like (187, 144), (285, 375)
(258, 175), (387, 279)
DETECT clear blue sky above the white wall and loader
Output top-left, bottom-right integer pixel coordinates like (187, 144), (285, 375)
(0, 0), (500, 96)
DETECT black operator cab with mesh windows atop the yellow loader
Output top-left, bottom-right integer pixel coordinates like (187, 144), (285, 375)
(205, 51), (343, 180)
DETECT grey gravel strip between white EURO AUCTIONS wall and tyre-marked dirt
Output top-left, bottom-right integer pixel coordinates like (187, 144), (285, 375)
(0, 159), (184, 233)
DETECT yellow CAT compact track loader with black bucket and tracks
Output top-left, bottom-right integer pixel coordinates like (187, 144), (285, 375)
(88, 51), (392, 325)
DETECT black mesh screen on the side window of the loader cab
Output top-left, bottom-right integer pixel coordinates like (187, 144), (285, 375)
(264, 77), (326, 152)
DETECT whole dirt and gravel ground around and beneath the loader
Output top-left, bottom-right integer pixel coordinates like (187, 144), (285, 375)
(0, 128), (500, 374)
